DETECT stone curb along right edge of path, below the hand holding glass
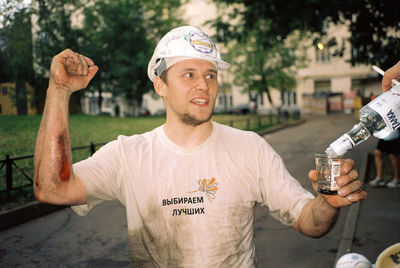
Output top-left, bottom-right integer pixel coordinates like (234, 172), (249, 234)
(333, 150), (369, 267)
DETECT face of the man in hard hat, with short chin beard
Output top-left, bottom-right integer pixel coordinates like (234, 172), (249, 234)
(159, 59), (218, 126)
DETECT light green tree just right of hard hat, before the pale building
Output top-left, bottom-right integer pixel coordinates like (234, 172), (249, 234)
(209, 2), (305, 106)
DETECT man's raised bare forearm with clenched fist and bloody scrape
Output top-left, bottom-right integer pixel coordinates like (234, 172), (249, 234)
(34, 49), (98, 204)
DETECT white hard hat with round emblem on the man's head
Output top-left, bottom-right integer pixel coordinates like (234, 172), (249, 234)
(147, 26), (230, 81)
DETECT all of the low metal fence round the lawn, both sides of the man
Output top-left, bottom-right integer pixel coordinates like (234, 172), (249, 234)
(0, 114), (297, 196)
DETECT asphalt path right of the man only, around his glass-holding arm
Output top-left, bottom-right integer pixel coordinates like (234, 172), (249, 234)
(254, 114), (376, 268)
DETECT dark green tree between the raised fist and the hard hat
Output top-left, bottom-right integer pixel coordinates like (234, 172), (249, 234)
(82, 0), (153, 114)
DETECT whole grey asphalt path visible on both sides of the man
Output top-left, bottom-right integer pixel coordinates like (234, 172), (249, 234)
(0, 114), (374, 268)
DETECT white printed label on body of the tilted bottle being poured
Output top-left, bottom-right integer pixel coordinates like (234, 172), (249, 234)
(368, 87), (400, 132)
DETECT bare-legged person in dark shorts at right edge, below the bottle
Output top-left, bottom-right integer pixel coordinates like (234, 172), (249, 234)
(368, 130), (400, 188)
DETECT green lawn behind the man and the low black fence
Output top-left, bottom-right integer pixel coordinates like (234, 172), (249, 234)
(0, 115), (280, 160)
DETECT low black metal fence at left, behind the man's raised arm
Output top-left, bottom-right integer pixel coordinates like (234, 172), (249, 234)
(0, 142), (105, 196)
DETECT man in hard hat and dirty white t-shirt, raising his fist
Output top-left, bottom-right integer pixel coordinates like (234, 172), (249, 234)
(35, 26), (366, 267)
